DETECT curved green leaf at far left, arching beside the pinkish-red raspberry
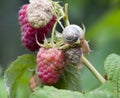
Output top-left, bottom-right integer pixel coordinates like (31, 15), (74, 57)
(4, 54), (36, 98)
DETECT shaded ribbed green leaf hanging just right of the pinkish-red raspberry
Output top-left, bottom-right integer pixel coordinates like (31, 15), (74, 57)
(55, 65), (81, 91)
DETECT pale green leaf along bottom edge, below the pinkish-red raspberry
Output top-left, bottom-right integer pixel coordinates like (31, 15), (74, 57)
(30, 86), (82, 98)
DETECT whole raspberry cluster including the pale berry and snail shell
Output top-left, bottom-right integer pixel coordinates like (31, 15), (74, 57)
(18, 0), (86, 91)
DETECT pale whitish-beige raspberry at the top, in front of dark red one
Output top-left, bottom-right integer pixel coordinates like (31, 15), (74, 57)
(27, 0), (53, 28)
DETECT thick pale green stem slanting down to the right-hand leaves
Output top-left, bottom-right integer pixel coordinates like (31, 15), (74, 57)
(81, 56), (105, 84)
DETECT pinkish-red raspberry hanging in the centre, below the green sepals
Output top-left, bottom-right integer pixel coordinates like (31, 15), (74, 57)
(36, 48), (65, 85)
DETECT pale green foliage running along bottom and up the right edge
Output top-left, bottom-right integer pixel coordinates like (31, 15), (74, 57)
(30, 54), (120, 98)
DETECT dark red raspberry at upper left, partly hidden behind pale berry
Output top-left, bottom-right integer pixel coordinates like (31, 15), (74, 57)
(18, 4), (56, 51)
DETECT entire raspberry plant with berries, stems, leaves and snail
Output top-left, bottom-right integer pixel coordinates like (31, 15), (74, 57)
(4, 0), (120, 98)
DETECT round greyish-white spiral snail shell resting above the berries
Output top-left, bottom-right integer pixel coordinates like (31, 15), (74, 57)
(62, 24), (84, 44)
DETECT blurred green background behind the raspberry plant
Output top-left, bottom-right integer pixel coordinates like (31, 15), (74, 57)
(0, 0), (120, 98)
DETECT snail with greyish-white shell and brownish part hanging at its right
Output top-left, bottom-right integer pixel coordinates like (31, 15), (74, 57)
(62, 24), (90, 53)
